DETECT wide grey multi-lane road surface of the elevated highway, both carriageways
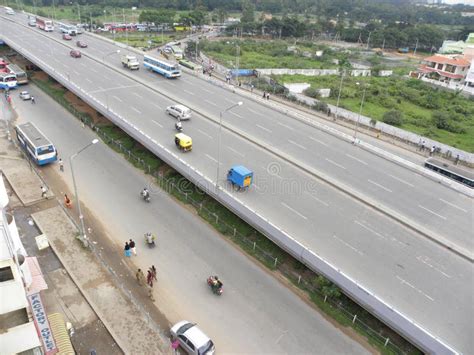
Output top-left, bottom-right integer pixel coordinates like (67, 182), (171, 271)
(0, 15), (473, 352)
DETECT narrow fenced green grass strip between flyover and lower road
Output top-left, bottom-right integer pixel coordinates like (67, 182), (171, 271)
(33, 68), (421, 354)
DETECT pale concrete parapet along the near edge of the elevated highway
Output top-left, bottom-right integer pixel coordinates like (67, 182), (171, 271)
(2, 23), (457, 354)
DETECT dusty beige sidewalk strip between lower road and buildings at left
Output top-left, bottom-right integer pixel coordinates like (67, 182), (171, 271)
(0, 136), (171, 354)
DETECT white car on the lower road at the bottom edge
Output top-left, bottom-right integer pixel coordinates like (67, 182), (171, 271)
(170, 320), (215, 355)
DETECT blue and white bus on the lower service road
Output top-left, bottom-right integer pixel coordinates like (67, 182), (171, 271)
(15, 122), (58, 165)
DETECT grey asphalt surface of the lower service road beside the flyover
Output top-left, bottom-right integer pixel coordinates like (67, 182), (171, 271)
(11, 88), (369, 354)
